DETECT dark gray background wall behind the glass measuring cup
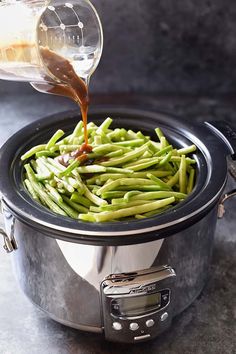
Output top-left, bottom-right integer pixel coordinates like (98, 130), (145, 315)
(0, 0), (236, 95)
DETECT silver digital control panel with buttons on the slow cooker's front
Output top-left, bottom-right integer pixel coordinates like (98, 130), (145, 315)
(101, 266), (176, 343)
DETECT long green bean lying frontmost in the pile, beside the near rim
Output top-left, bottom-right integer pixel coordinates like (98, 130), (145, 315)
(91, 197), (175, 222)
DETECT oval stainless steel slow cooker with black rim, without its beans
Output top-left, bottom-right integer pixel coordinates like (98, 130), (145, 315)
(0, 106), (236, 343)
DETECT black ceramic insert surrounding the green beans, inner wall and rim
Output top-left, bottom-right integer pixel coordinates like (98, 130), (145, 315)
(0, 107), (231, 245)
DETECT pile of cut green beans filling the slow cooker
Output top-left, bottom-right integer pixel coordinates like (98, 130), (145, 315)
(21, 118), (196, 222)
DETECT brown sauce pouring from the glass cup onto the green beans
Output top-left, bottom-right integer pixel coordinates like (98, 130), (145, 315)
(6, 43), (95, 165)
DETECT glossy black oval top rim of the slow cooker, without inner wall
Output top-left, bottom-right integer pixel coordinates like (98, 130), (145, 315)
(0, 107), (227, 244)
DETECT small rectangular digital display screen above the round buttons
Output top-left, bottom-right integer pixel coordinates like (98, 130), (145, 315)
(112, 293), (161, 317)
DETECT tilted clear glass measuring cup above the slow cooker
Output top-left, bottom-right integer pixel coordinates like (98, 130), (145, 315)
(0, 0), (103, 95)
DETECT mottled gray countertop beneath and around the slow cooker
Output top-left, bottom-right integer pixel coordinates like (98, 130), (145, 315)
(0, 86), (236, 354)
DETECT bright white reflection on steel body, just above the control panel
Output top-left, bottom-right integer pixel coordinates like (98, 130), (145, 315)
(57, 240), (163, 291)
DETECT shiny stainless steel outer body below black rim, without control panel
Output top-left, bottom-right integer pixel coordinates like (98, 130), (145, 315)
(1, 202), (217, 331)
